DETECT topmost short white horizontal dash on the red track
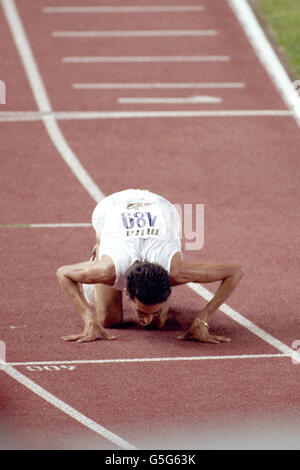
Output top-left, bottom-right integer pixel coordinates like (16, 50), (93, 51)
(42, 5), (205, 13)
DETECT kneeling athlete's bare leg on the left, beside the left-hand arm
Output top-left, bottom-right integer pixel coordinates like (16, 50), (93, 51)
(93, 284), (123, 328)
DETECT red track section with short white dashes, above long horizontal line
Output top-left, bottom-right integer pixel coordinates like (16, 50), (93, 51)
(18, 0), (286, 111)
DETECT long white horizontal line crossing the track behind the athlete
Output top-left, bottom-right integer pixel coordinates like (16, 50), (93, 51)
(0, 109), (293, 123)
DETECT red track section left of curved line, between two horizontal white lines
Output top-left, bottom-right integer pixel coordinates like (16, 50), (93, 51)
(0, 120), (94, 225)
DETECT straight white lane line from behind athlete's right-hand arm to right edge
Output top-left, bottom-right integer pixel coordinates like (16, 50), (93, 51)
(188, 283), (300, 362)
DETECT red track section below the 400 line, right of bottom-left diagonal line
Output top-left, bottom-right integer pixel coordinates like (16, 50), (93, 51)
(2, 358), (299, 449)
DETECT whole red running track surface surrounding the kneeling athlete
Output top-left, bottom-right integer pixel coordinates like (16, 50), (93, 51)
(0, 0), (300, 449)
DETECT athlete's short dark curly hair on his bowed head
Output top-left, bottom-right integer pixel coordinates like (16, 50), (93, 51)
(126, 261), (171, 305)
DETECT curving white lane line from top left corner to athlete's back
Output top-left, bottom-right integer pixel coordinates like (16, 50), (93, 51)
(2, 0), (104, 201)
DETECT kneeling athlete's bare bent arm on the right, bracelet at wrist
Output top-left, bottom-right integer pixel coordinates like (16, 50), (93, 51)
(170, 253), (243, 343)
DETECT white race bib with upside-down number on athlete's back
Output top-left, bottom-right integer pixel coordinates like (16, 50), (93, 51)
(106, 203), (167, 239)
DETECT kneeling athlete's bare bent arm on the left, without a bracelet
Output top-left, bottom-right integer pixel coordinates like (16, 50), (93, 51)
(56, 256), (116, 343)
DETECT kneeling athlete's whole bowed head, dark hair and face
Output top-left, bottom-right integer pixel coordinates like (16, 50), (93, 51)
(126, 261), (171, 326)
